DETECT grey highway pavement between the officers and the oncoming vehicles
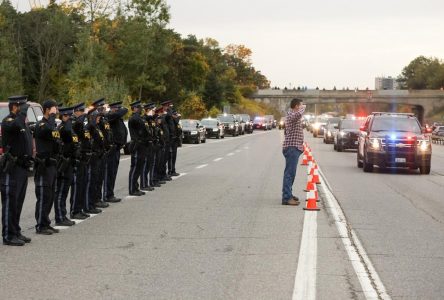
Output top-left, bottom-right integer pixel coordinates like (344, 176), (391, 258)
(0, 130), (444, 299)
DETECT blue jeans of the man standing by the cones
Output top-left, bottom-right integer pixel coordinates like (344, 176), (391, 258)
(282, 147), (302, 202)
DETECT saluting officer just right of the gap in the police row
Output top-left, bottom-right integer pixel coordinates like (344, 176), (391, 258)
(128, 101), (146, 196)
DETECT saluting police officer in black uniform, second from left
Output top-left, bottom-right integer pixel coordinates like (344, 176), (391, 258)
(34, 100), (60, 235)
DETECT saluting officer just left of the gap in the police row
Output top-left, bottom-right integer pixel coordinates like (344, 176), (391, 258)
(103, 101), (128, 203)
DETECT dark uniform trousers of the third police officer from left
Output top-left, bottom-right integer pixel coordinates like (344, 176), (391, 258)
(54, 165), (73, 222)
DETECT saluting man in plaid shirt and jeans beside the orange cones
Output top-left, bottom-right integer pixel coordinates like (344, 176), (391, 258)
(282, 98), (305, 206)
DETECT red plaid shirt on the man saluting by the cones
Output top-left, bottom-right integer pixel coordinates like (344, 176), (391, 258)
(282, 107), (305, 151)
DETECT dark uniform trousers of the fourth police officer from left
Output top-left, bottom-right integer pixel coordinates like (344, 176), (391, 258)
(70, 162), (87, 215)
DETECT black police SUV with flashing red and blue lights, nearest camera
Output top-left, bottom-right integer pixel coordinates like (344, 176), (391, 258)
(357, 112), (432, 174)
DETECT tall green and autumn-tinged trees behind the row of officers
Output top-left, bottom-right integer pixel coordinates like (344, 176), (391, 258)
(0, 0), (269, 115)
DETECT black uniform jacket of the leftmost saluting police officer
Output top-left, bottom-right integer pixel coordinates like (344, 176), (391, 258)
(2, 113), (32, 160)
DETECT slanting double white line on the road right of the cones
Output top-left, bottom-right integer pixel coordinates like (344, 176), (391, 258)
(319, 168), (391, 300)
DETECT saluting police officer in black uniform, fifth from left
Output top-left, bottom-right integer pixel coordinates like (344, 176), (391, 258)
(92, 98), (110, 208)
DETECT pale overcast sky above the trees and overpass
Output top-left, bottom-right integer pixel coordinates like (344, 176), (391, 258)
(11, 0), (444, 89)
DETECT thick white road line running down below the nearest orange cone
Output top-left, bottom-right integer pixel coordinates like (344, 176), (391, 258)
(292, 211), (318, 300)
